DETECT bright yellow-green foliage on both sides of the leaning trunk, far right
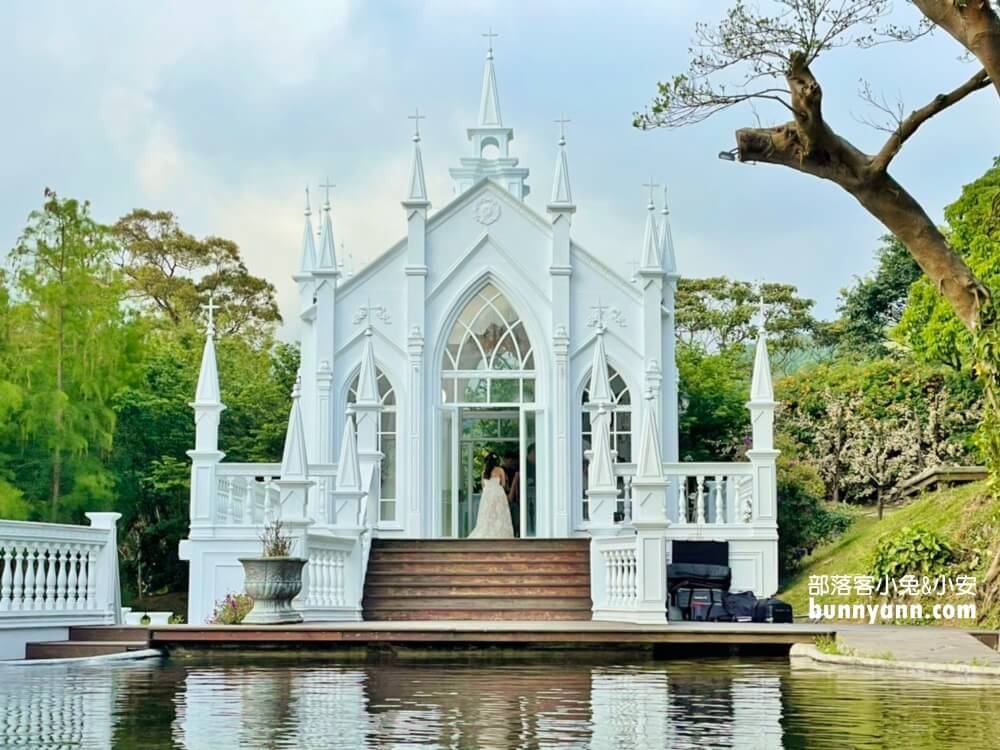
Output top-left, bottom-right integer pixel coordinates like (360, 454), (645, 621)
(894, 158), (1000, 370)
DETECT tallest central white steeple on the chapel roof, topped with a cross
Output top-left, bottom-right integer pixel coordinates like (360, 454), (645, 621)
(449, 29), (529, 200)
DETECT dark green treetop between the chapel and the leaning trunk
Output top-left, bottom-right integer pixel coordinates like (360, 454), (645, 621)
(830, 235), (922, 357)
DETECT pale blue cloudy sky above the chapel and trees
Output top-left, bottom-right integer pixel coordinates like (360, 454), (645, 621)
(0, 0), (1000, 335)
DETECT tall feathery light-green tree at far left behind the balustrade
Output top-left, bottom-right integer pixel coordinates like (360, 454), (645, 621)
(6, 190), (141, 519)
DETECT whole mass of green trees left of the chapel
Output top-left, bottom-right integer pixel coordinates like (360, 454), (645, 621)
(0, 191), (298, 595)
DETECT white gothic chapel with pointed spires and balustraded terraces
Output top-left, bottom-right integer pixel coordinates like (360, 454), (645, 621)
(181, 48), (777, 623)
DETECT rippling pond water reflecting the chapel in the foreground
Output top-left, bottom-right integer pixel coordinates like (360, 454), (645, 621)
(0, 655), (1000, 750)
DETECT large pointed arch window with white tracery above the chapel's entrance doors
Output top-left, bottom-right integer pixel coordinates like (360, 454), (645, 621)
(441, 284), (535, 404)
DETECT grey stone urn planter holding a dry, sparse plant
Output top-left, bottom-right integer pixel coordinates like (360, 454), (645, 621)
(240, 521), (306, 625)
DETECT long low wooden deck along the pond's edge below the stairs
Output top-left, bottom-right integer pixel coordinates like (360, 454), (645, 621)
(149, 620), (837, 650)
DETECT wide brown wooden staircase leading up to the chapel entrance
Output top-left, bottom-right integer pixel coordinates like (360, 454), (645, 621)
(363, 539), (592, 620)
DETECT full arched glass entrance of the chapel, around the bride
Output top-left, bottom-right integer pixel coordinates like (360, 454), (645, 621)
(439, 284), (538, 538)
